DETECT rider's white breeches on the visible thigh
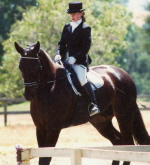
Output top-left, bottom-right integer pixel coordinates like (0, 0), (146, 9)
(72, 64), (87, 86)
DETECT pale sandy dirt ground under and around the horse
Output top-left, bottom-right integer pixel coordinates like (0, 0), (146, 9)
(0, 111), (150, 165)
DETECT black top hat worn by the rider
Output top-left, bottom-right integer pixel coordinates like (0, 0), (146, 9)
(66, 2), (85, 14)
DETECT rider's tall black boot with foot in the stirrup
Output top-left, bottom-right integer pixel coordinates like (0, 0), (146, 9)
(83, 82), (100, 116)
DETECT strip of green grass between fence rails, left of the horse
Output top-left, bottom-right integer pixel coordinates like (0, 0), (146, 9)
(0, 101), (30, 112)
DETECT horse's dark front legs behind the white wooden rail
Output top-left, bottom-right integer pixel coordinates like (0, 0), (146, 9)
(36, 128), (60, 165)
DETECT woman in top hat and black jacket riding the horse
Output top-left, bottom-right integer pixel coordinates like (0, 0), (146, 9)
(54, 2), (100, 116)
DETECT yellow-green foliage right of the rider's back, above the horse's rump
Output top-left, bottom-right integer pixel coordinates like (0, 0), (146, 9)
(91, 2), (131, 66)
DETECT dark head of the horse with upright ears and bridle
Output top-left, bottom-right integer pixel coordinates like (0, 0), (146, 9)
(15, 42), (42, 101)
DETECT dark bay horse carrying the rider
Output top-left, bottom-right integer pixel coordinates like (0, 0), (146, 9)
(15, 42), (150, 165)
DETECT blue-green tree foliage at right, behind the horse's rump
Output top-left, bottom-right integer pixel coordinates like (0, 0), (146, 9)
(117, 24), (150, 94)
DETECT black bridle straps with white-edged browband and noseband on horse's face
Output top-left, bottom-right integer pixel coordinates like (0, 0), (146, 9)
(21, 57), (42, 88)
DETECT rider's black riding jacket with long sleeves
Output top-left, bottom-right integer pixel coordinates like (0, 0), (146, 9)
(56, 21), (91, 67)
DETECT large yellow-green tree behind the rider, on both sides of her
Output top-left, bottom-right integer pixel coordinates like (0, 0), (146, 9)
(0, 0), (130, 97)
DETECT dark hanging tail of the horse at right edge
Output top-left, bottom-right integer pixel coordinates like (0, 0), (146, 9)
(133, 104), (150, 145)
